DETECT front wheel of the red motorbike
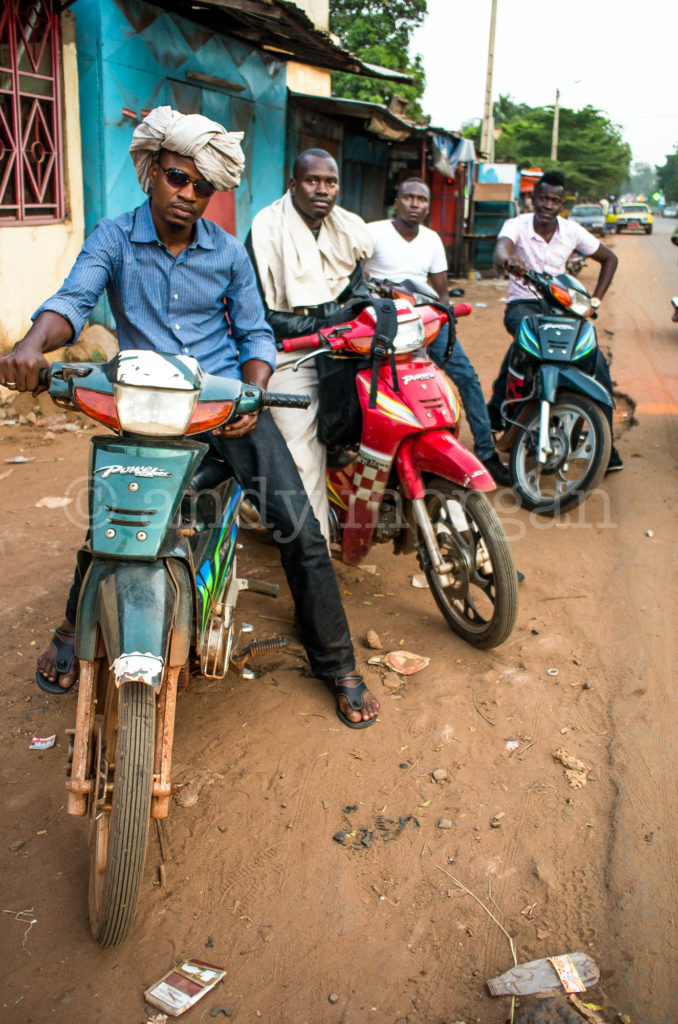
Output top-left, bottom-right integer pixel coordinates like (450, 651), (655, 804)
(419, 477), (518, 648)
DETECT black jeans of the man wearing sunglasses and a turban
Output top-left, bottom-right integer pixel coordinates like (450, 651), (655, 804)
(66, 410), (355, 682)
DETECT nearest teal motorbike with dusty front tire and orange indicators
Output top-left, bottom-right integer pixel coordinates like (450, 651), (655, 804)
(41, 351), (309, 946)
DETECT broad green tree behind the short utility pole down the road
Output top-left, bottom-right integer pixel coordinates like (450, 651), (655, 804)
(495, 105), (631, 199)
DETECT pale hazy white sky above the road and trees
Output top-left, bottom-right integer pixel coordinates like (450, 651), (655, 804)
(411, 0), (678, 164)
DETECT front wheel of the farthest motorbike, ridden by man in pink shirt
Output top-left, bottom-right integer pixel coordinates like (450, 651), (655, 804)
(509, 391), (612, 515)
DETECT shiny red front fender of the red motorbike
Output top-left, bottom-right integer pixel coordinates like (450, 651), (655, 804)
(395, 430), (496, 499)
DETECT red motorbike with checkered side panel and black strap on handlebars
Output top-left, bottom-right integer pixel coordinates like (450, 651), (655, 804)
(283, 290), (518, 647)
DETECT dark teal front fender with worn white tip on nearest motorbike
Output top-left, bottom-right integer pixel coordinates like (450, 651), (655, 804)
(76, 558), (193, 690)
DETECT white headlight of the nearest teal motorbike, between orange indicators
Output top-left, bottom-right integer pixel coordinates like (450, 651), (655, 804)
(113, 384), (200, 437)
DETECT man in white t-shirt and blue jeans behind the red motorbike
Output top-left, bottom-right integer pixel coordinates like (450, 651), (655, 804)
(364, 178), (509, 485)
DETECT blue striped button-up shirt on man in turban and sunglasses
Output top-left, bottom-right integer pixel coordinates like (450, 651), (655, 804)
(33, 201), (276, 378)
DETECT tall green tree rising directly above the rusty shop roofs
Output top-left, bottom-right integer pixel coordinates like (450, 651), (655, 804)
(330, 0), (427, 120)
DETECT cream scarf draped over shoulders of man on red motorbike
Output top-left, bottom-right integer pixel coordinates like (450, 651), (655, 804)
(252, 191), (373, 312)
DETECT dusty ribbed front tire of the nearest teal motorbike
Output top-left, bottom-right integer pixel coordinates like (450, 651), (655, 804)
(89, 681), (156, 946)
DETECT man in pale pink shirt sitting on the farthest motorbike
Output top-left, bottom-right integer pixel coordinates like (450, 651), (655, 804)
(488, 171), (624, 473)
